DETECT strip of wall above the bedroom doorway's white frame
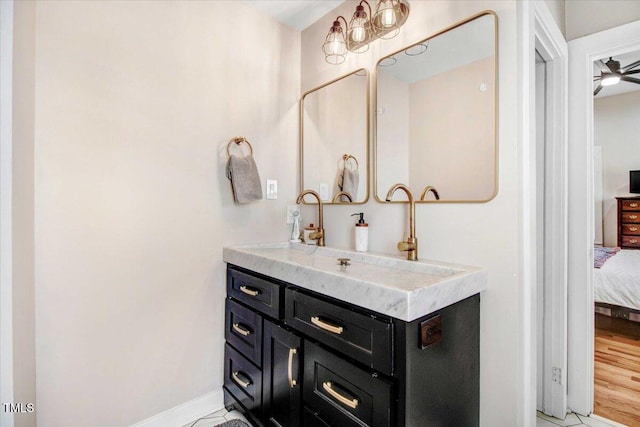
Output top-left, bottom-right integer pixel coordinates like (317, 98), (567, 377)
(565, 0), (640, 40)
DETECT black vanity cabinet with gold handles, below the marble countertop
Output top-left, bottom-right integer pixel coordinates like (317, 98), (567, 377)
(224, 265), (480, 427)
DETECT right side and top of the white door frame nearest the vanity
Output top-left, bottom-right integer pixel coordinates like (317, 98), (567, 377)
(535, 2), (569, 419)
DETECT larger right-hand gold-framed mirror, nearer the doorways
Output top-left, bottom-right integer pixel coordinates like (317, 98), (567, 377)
(374, 12), (498, 203)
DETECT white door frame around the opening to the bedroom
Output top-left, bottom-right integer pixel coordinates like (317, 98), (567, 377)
(567, 21), (640, 415)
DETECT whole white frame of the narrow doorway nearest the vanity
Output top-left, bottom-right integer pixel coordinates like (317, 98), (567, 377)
(516, 1), (568, 427)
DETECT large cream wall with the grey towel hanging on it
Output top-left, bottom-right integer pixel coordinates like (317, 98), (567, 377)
(35, 1), (300, 427)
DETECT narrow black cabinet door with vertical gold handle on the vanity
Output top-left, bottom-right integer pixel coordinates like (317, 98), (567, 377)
(262, 320), (302, 427)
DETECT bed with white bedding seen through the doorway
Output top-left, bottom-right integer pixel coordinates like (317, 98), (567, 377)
(593, 248), (640, 321)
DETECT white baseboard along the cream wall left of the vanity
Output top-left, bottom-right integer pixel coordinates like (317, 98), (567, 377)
(131, 389), (224, 427)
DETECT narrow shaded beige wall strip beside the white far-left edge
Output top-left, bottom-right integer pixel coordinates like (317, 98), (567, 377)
(12, 1), (37, 427)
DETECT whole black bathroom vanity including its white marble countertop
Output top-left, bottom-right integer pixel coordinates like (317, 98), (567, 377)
(223, 243), (486, 427)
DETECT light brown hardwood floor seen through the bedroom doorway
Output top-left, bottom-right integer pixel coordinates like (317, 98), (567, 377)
(594, 318), (640, 427)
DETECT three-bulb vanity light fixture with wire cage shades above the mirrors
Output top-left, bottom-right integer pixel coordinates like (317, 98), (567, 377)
(322, 0), (409, 65)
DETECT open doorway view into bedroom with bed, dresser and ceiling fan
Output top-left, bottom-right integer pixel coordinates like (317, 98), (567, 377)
(593, 51), (640, 425)
